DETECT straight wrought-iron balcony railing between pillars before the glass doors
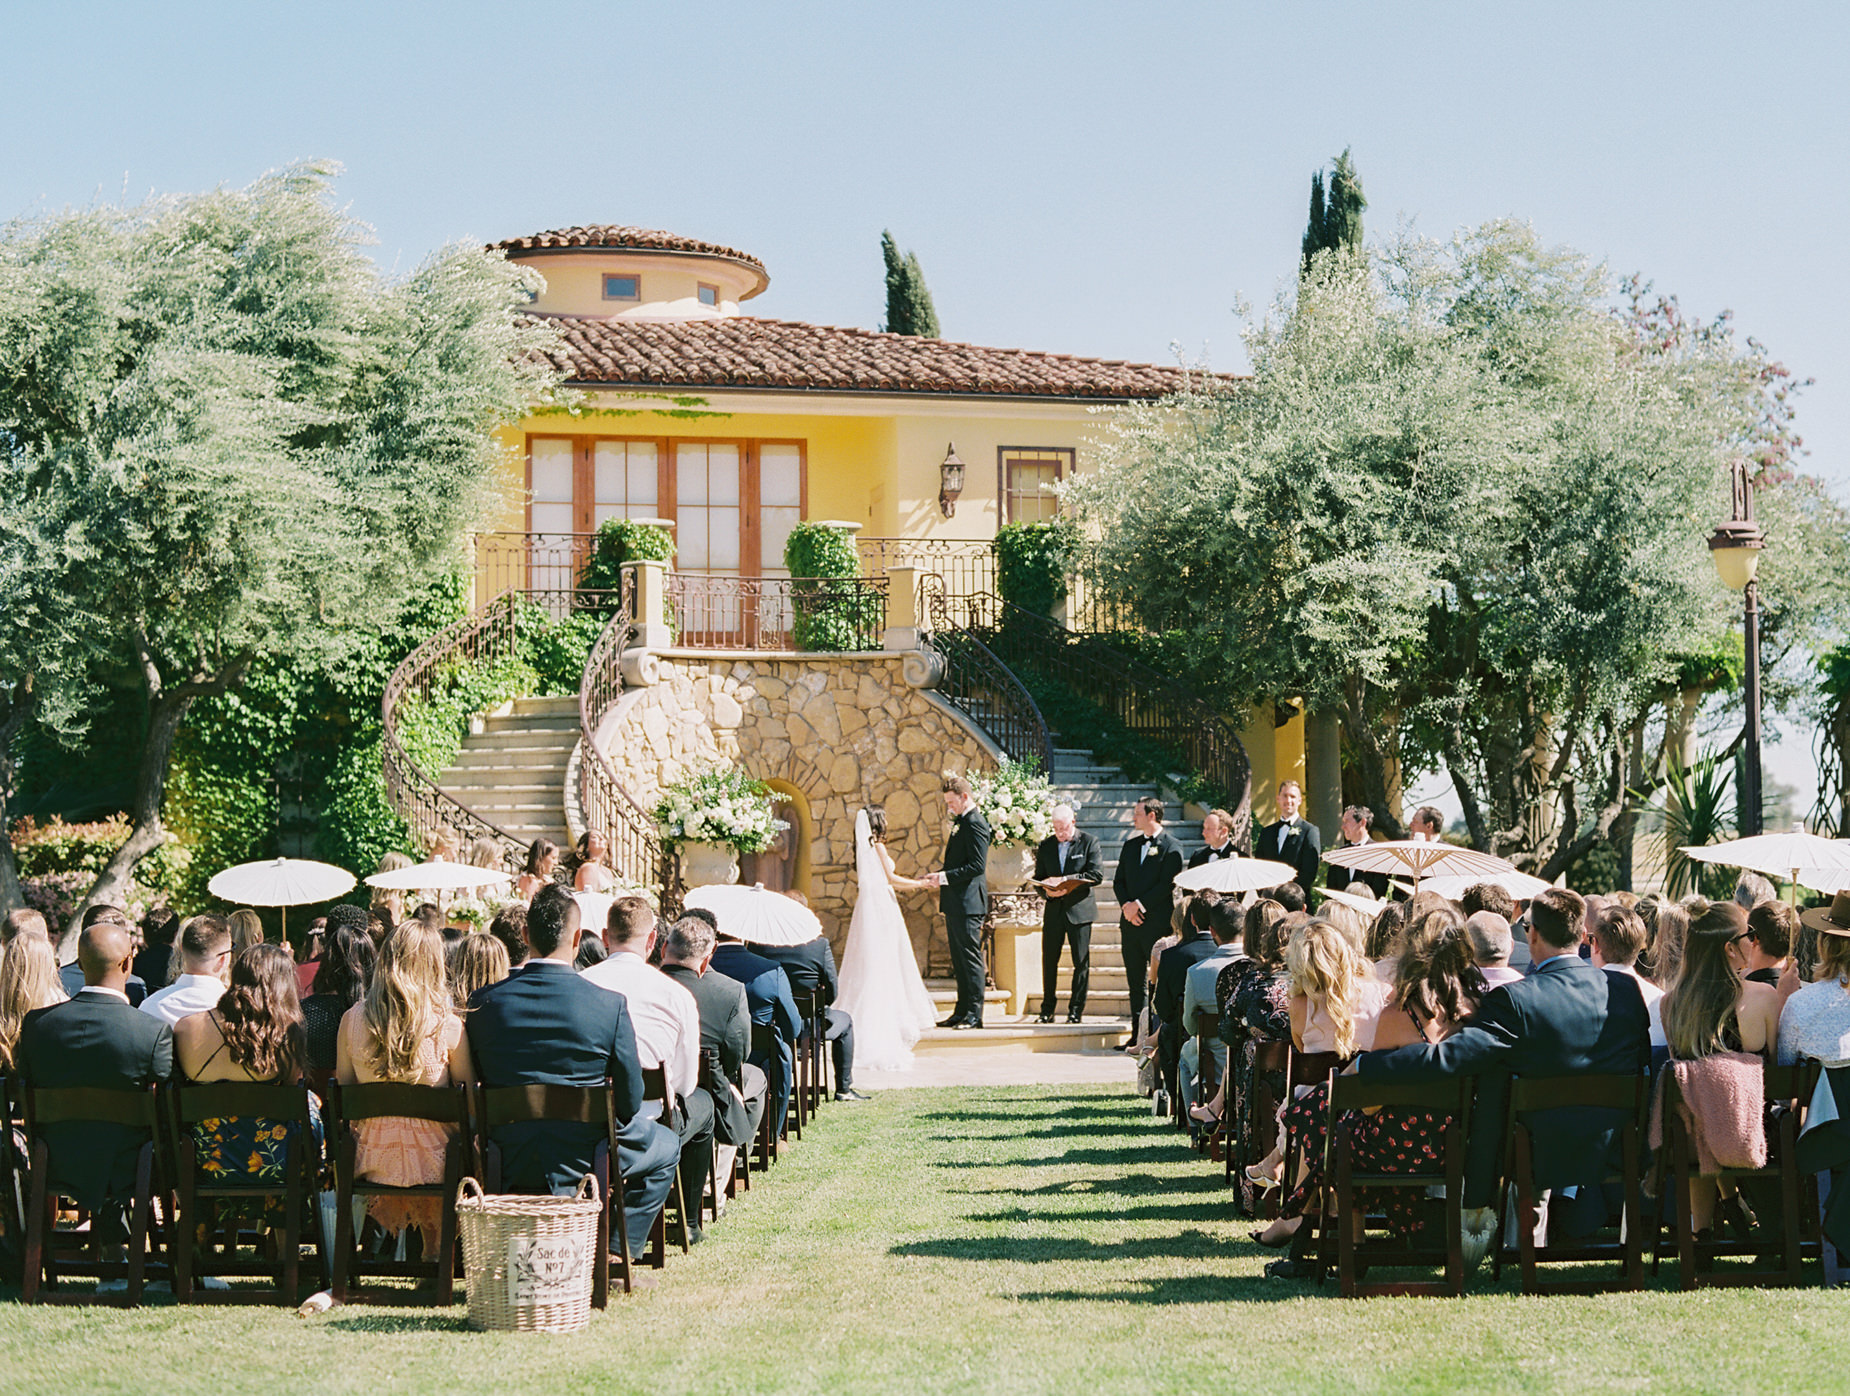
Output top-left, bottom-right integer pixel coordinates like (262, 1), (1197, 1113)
(666, 571), (886, 651)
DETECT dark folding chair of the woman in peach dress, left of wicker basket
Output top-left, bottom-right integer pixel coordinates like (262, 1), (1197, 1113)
(326, 1082), (468, 1307)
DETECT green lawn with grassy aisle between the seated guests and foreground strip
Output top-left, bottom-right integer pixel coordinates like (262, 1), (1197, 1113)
(0, 1087), (1850, 1396)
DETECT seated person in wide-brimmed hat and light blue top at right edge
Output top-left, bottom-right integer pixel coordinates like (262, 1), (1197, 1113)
(1776, 891), (1850, 1255)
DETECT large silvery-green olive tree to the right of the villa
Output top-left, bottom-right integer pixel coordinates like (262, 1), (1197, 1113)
(1067, 222), (1841, 876)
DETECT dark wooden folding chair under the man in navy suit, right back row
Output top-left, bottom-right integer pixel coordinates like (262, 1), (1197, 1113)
(1497, 1069), (1650, 1294)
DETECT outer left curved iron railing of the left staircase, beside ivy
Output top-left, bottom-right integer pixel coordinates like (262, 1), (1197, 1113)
(379, 592), (527, 869)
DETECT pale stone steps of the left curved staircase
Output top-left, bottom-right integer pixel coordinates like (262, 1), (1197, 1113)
(437, 697), (579, 849)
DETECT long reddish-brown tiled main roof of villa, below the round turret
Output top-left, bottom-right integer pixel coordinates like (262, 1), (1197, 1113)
(529, 316), (1213, 401)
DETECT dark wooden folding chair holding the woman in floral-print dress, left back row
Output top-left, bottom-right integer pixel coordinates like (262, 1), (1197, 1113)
(167, 1082), (327, 1304)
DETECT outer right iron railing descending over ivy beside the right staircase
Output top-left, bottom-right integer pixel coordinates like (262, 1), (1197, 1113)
(971, 597), (1252, 849)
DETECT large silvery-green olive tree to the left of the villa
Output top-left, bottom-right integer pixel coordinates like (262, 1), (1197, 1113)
(0, 165), (553, 924)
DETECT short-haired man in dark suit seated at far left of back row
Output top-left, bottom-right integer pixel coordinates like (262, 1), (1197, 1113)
(7, 924), (174, 1239)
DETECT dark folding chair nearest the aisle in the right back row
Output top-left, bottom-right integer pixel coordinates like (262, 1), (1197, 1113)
(1325, 1074), (1473, 1298)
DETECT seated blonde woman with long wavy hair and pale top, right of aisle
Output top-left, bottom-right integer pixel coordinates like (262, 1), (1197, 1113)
(1247, 912), (1391, 1272)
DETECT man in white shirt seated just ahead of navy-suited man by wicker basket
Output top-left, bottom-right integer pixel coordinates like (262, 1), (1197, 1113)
(583, 897), (712, 1241)
